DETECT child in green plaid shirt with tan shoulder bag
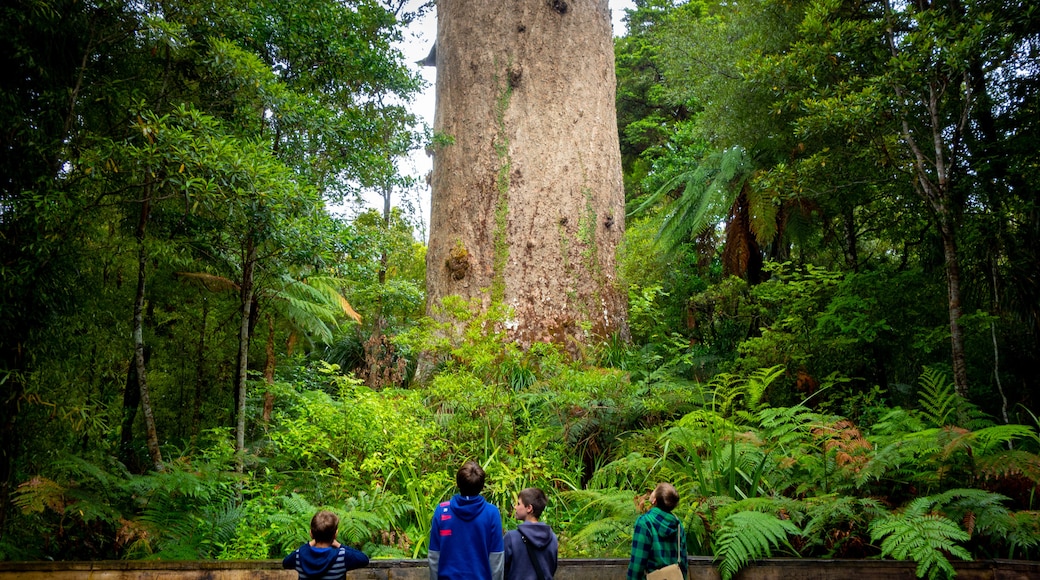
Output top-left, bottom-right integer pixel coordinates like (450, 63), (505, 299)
(628, 483), (690, 580)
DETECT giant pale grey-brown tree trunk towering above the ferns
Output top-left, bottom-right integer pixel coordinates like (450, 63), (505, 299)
(426, 0), (627, 346)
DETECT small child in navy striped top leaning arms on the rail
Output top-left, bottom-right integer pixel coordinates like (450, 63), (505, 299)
(282, 511), (368, 580)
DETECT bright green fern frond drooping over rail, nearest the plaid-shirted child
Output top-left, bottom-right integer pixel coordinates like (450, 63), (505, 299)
(714, 511), (802, 580)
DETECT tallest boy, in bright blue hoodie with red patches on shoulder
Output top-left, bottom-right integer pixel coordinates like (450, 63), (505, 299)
(430, 462), (503, 580)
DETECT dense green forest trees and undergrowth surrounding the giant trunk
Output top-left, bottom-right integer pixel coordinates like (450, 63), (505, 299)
(0, 0), (1040, 579)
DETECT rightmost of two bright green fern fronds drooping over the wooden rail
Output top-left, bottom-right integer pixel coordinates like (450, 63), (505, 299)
(870, 498), (971, 579)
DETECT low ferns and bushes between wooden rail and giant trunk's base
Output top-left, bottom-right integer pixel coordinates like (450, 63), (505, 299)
(8, 305), (1040, 579)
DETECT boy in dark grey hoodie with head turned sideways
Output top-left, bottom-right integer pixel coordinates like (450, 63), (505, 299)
(504, 487), (558, 580)
